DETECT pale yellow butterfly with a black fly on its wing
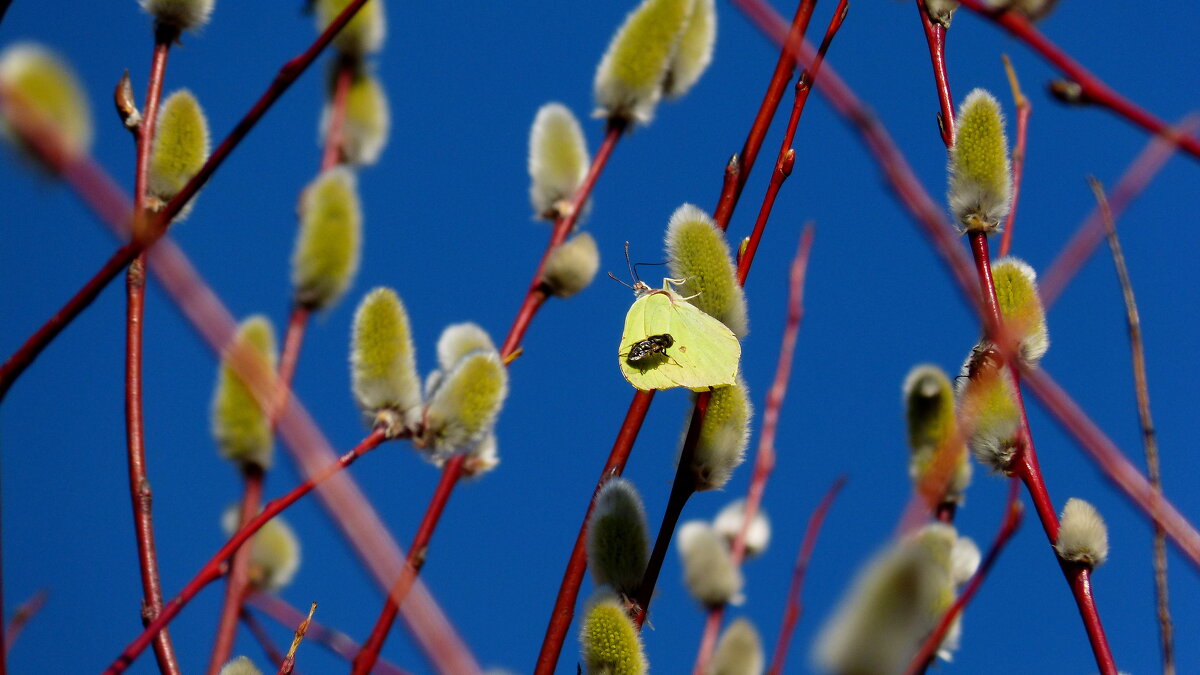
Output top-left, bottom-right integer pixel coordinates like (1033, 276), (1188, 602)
(618, 279), (742, 392)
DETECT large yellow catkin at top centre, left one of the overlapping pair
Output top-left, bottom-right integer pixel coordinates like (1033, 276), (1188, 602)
(594, 0), (695, 124)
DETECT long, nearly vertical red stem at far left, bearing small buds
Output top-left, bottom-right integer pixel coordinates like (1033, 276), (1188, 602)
(125, 24), (180, 675)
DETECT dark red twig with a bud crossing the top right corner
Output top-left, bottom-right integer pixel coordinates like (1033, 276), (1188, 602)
(945, 0), (1200, 159)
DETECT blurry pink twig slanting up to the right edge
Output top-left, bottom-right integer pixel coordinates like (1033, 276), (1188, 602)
(1039, 113), (1200, 310)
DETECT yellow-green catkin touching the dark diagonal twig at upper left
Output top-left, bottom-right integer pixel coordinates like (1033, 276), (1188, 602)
(146, 89), (209, 208)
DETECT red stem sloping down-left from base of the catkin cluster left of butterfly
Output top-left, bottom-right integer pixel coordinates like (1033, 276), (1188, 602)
(104, 429), (386, 675)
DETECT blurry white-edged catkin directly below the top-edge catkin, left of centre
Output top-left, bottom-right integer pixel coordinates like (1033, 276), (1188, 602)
(320, 65), (391, 166)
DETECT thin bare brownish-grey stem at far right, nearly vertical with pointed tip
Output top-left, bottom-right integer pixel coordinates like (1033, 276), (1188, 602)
(1088, 178), (1175, 675)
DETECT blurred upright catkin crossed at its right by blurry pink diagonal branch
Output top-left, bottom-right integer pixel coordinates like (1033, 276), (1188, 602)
(212, 315), (276, 470)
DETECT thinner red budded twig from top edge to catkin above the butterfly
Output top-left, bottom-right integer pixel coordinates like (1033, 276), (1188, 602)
(713, 0), (816, 229)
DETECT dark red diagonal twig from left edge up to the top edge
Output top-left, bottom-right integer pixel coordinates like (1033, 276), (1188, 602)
(0, 0), (367, 399)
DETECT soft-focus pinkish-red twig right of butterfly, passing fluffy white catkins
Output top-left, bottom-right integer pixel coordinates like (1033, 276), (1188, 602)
(692, 226), (812, 675)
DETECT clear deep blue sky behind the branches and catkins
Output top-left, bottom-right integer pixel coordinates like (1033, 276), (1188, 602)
(0, 0), (1200, 675)
